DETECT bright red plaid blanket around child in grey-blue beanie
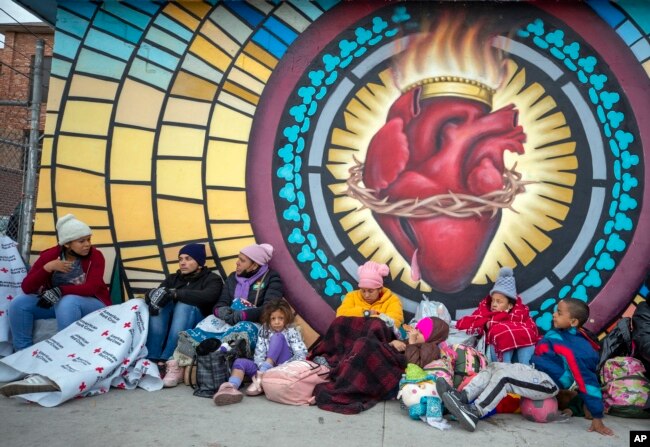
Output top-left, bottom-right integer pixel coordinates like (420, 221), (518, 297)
(456, 295), (539, 359)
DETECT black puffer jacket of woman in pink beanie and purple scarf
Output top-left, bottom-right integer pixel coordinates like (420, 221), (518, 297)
(214, 270), (284, 323)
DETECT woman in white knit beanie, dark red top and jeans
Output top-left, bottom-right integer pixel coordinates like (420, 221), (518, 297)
(9, 214), (111, 351)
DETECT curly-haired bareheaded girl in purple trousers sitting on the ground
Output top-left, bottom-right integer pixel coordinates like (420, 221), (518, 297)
(213, 299), (307, 405)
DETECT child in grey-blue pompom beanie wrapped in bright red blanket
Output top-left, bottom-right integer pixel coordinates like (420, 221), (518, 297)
(456, 267), (539, 365)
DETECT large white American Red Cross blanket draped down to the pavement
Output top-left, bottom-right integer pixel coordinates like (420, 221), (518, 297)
(0, 299), (162, 407)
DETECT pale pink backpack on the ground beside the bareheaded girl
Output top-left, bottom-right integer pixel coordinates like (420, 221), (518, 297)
(262, 360), (330, 405)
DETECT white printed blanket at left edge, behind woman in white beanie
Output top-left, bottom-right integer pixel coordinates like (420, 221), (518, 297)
(0, 236), (27, 357)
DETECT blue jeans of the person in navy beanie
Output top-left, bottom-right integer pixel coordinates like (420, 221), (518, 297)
(147, 302), (203, 360)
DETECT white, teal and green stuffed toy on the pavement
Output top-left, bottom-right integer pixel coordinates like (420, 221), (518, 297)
(397, 363), (451, 430)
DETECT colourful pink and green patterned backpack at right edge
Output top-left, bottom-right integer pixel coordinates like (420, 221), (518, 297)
(600, 357), (650, 419)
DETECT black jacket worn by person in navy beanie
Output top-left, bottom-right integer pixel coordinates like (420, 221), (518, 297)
(153, 268), (223, 317)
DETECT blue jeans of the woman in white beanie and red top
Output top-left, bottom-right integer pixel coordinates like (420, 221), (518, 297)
(9, 294), (104, 351)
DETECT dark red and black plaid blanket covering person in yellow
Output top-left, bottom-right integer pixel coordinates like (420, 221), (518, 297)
(312, 317), (406, 414)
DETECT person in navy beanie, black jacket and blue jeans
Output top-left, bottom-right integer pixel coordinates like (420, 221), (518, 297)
(145, 244), (223, 387)
